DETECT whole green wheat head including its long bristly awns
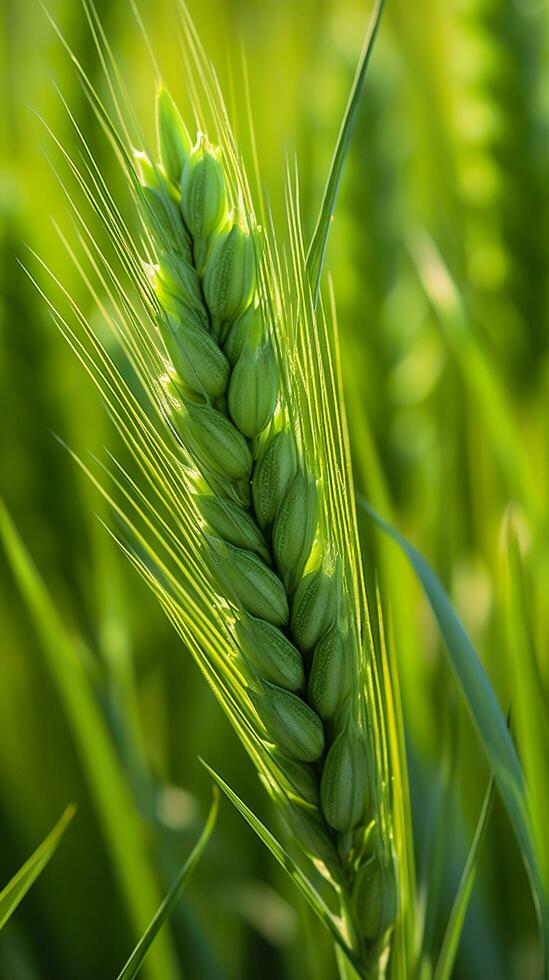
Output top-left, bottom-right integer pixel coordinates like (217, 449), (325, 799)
(34, 3), (399, 977)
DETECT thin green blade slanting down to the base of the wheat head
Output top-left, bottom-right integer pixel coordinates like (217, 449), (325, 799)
(197, 759), (360, 970)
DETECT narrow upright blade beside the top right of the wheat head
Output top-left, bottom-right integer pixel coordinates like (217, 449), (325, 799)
(306, 0), (385, 307)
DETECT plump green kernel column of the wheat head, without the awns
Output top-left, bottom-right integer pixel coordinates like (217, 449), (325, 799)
(130, 89), (395, 976)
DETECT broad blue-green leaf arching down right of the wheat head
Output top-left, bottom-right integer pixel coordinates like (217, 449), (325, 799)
(358, 498), (549, 970)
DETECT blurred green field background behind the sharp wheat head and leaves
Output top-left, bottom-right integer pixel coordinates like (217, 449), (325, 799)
(0, 0), (549, 980)
